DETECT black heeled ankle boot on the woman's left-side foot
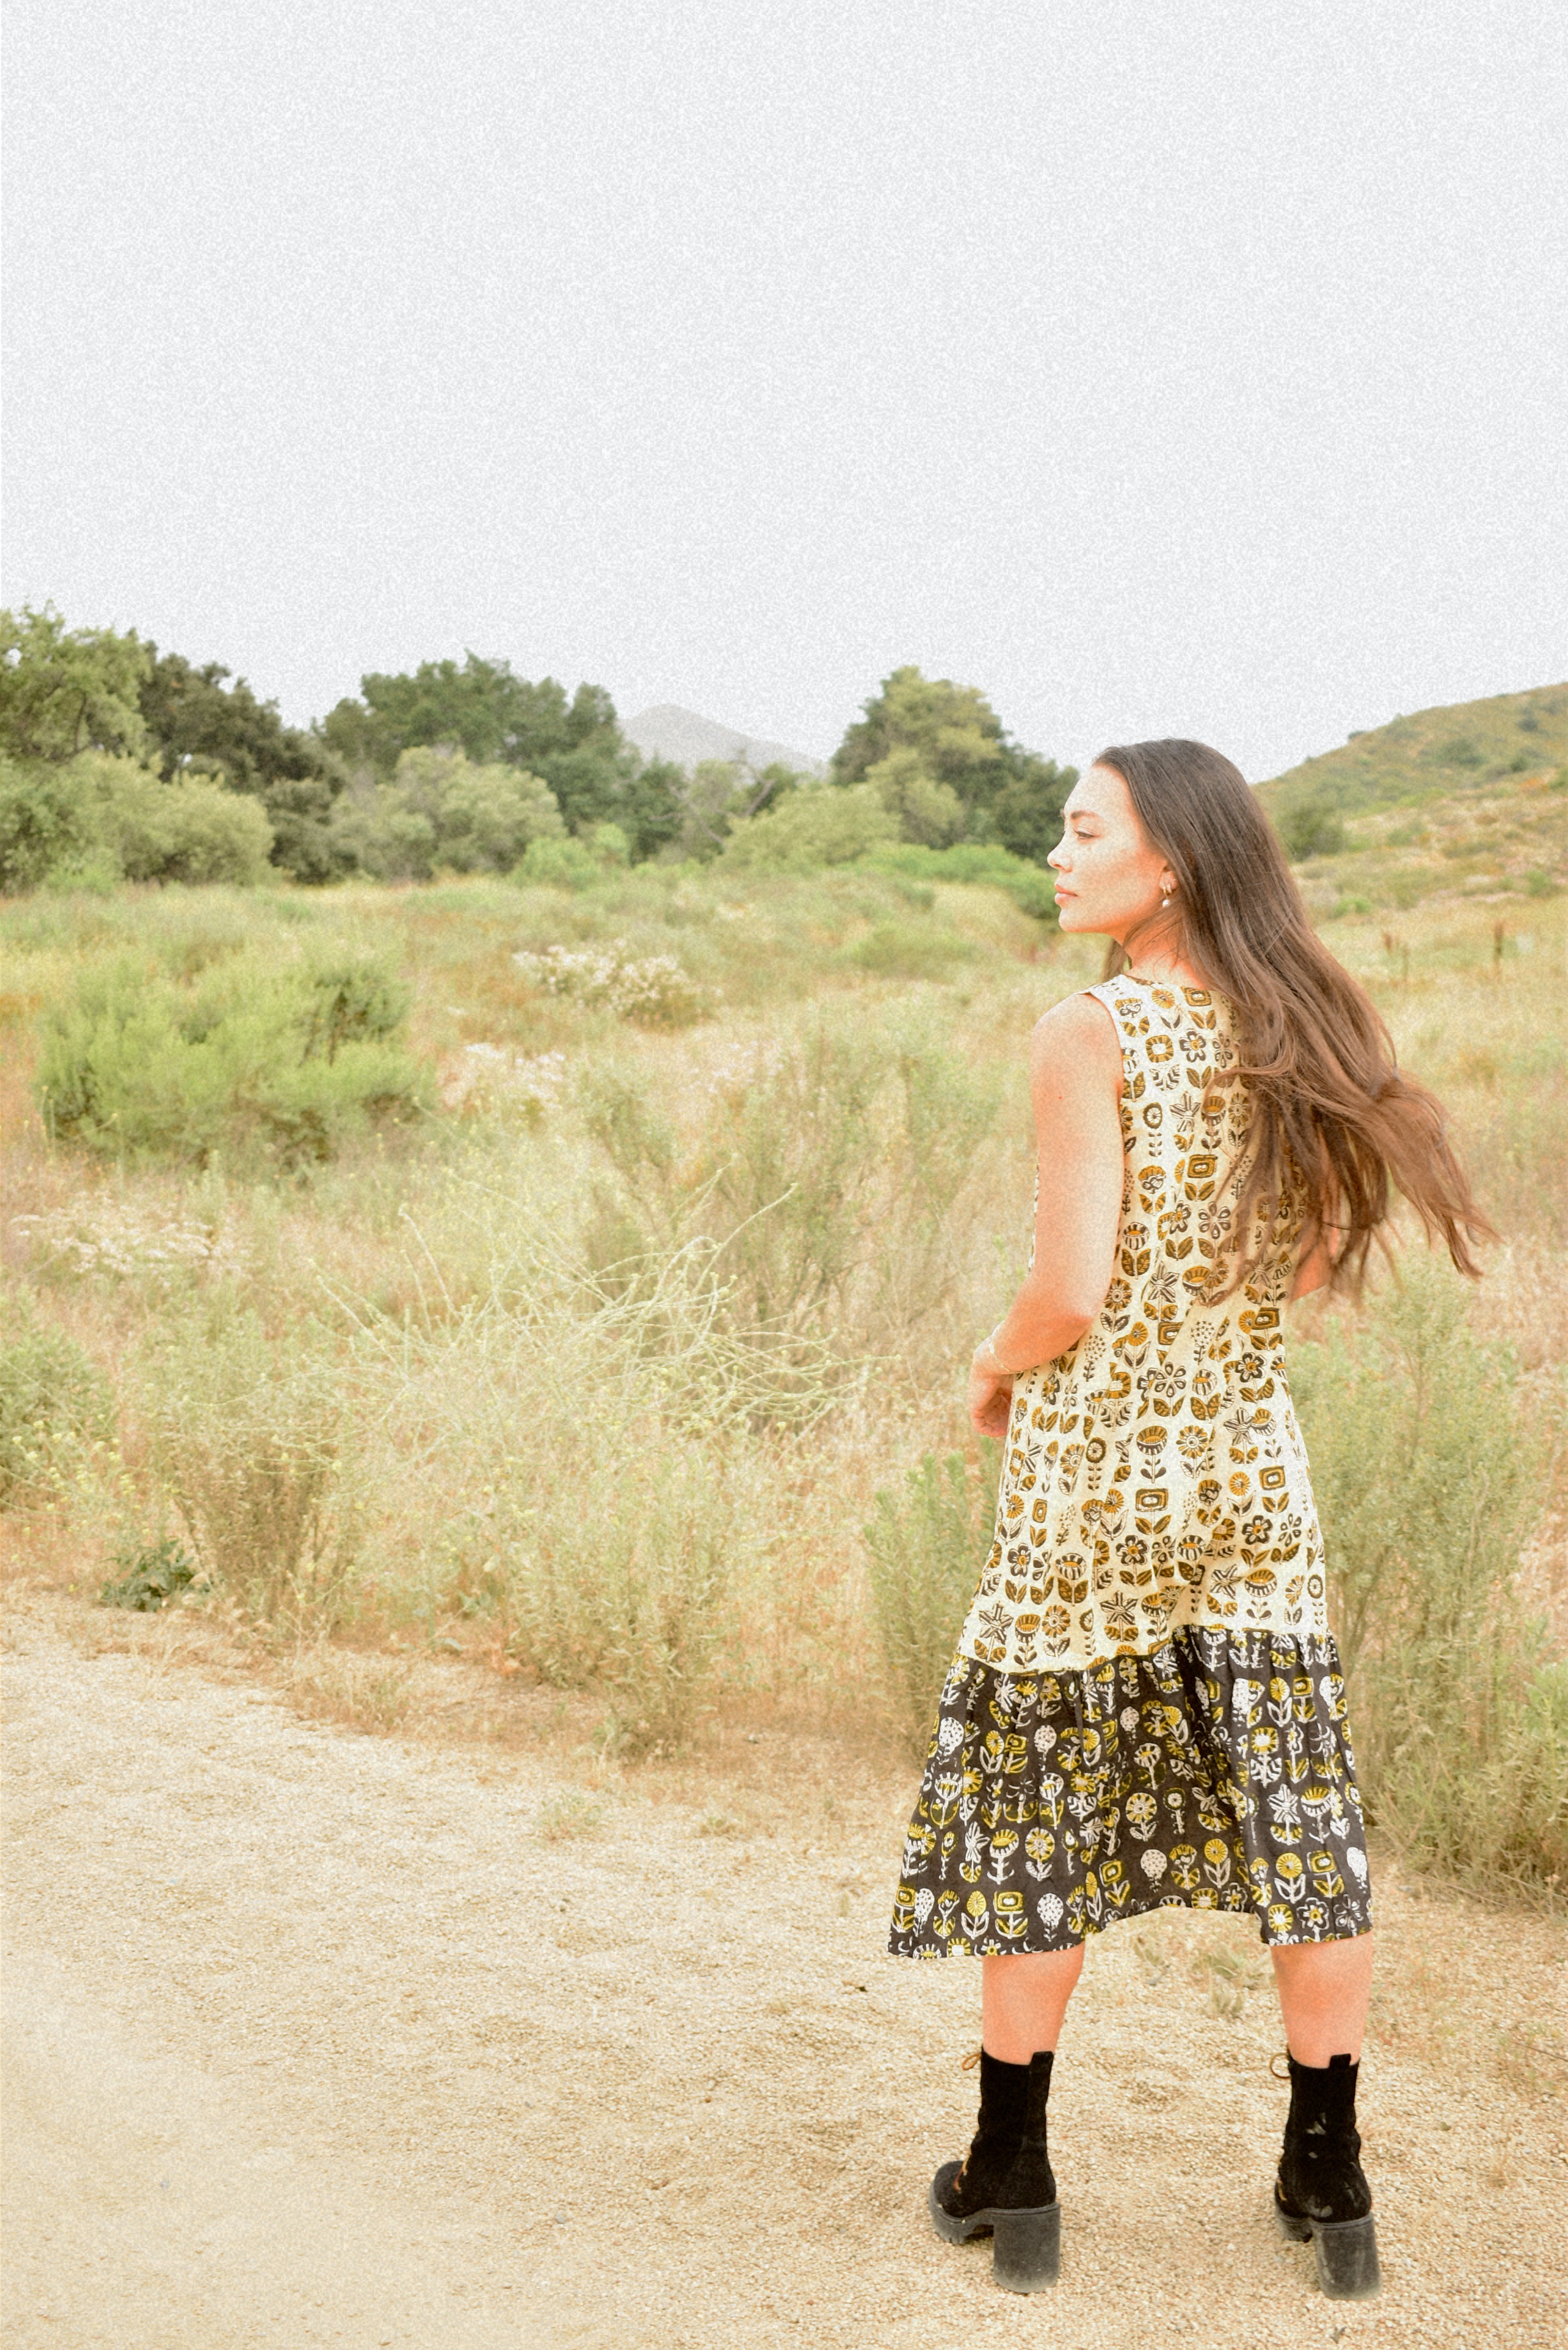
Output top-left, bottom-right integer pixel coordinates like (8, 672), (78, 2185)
(931, 2049), (1063, 2294)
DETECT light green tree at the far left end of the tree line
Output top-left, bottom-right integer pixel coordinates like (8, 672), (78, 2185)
(0, 604), (153, 766)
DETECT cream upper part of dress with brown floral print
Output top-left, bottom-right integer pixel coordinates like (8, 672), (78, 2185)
(959, 977), (1328, 1673)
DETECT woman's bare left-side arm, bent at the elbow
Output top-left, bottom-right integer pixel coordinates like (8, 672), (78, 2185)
(969, 996), (1121, 1436)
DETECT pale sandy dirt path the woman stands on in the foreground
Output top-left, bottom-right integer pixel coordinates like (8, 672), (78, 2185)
(5, 1605), (1568, 2350)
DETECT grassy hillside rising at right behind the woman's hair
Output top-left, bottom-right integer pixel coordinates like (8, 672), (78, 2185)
(1258, 684), (1568, 912)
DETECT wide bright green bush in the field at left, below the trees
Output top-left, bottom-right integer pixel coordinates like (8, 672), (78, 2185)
(38, 957), (423, 1168)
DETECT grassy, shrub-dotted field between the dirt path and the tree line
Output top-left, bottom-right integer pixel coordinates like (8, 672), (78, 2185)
(2, 865), (1568, 1901)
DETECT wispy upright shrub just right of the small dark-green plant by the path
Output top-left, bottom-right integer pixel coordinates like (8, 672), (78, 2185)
(143, 1295), (348, 1629)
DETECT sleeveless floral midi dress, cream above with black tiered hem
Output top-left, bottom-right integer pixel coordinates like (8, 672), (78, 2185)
(889, 977), (1370, 1957)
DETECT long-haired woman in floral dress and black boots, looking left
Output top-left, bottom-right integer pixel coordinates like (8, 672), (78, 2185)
(891, 740), (1491, 2296)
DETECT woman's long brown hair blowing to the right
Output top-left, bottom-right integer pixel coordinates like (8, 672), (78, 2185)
(1096, 740), (1495, 1288)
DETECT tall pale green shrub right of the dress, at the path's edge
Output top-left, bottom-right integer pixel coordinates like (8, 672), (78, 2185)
(1295, 1262), (1568, 1887)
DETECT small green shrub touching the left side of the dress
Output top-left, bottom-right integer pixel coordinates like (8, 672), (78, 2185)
(863, 1438), (1001, 1748)
